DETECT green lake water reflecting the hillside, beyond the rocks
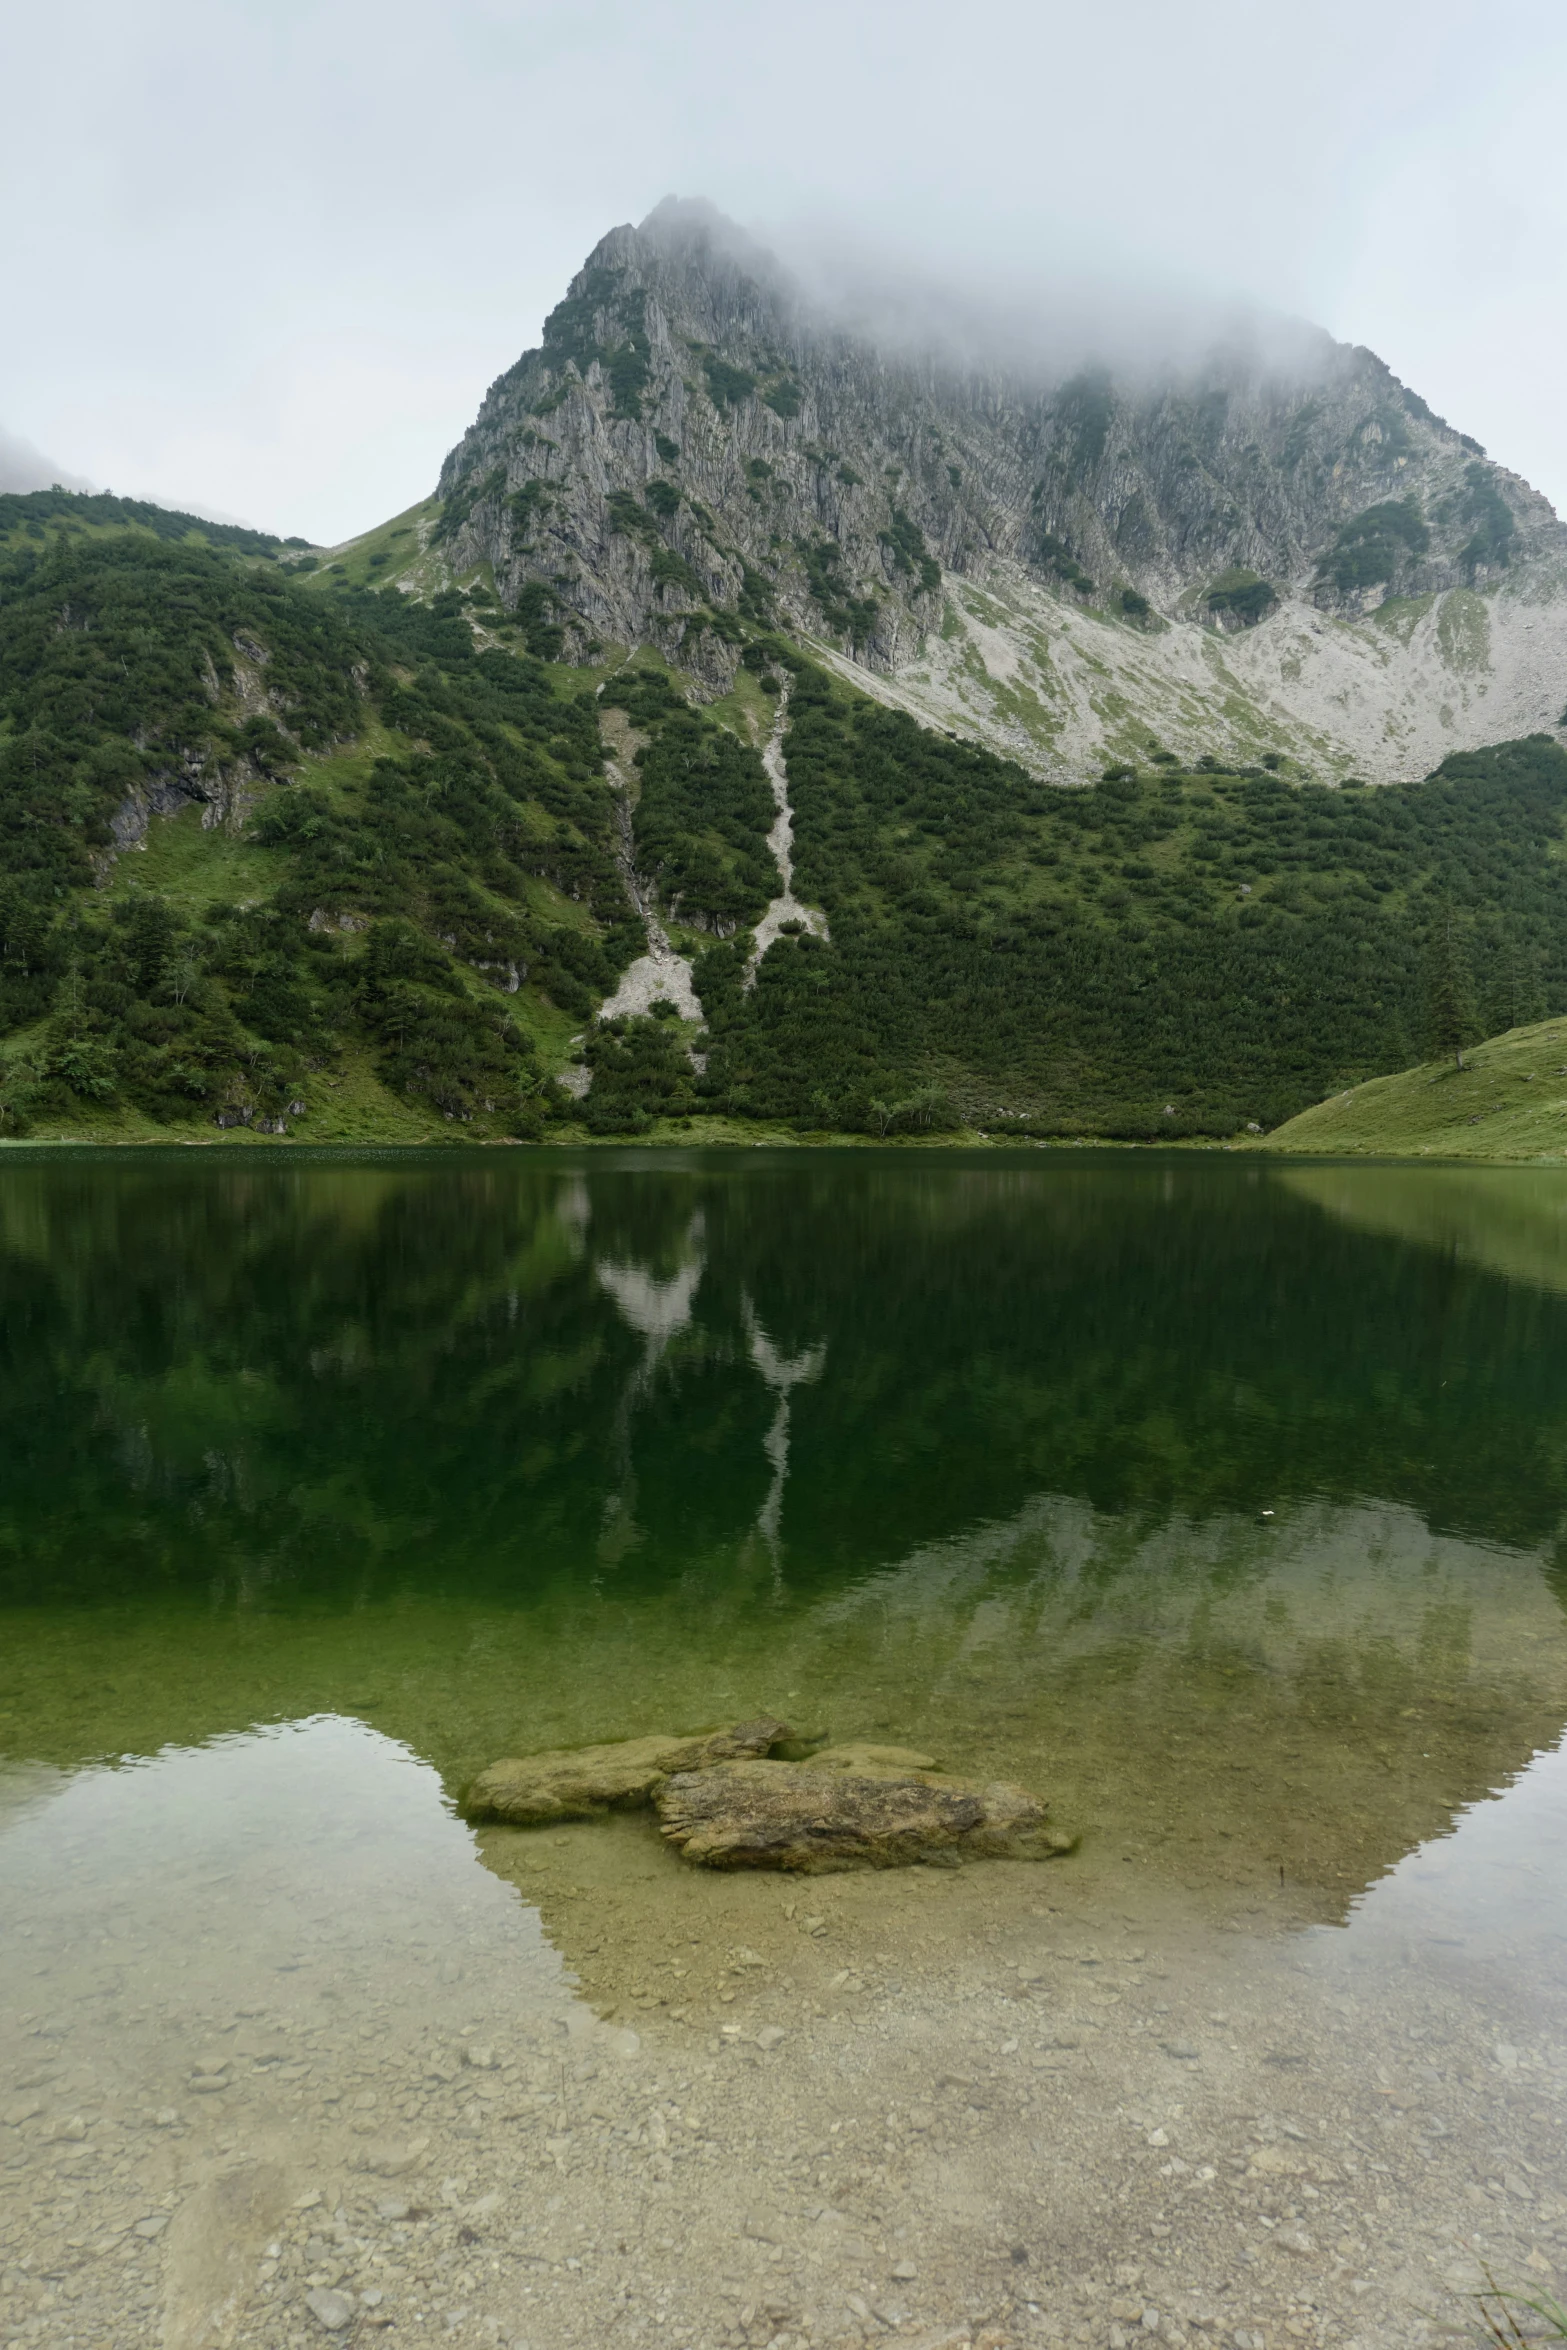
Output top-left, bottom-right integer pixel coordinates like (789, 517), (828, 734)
(0, 1152), (1567, 1911)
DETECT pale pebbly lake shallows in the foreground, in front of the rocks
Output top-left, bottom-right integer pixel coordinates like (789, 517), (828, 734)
(0, 1716), (1567, 2350)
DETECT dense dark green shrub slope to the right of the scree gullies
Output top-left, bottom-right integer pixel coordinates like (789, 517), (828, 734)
(610, 660), (1567, 1140)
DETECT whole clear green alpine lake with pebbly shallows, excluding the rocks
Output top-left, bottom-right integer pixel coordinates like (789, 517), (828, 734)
(0, 1149), (1567, 2350)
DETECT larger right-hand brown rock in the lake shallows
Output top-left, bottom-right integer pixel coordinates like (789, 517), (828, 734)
(653, 1760), (1074, 1873)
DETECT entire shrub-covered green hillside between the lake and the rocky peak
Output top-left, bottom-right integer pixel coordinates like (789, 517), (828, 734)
(0, 494), (1567, 1140)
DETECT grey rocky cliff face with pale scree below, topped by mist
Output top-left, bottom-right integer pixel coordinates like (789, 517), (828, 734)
(435, 202), (1567, 773)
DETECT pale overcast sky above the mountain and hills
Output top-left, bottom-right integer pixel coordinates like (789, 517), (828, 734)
(0, 0), (1567, 541)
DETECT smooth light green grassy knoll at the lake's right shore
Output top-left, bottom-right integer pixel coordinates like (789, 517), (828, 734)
(1264, 999), (1567, 1159)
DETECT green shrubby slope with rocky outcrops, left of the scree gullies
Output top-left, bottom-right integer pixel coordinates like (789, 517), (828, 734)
(0, 531), (637, 1137)
